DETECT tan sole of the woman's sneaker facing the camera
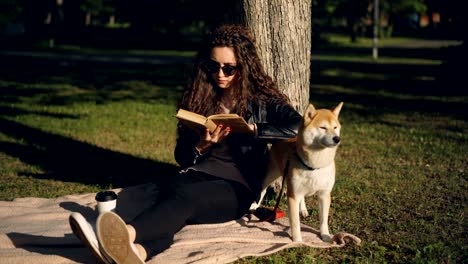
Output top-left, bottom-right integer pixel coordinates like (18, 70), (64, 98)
(96, 212), (145, 264)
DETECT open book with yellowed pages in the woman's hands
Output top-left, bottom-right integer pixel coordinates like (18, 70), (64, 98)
(176, 109), (253, 133)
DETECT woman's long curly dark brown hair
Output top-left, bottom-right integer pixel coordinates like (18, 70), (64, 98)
(179, 24), (289, 116)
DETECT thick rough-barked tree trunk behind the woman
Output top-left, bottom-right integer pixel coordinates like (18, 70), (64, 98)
(240, 0), (312, 114)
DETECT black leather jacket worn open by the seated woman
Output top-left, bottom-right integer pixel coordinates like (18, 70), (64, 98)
(174, 102), (302, 195)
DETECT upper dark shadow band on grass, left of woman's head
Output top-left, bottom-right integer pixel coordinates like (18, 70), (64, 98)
(0, 56), (189, 105)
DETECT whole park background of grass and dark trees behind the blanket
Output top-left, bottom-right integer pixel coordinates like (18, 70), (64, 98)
(0, 0), (468, 263)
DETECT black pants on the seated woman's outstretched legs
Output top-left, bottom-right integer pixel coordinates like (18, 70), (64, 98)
(129, 170), (253, 257)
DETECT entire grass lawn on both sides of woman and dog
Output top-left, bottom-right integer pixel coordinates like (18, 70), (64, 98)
(0, 36), (468, 263)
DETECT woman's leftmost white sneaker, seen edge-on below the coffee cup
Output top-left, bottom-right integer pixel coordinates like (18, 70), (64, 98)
(68, 212), (112, 264)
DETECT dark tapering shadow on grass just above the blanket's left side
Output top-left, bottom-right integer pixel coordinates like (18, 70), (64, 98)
(0, 118), (176, 188)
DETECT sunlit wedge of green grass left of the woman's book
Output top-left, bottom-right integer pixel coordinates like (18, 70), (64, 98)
(6, 101), (176, 163)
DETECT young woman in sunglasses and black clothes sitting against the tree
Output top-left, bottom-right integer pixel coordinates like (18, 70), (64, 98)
(71, 25), (301, 263)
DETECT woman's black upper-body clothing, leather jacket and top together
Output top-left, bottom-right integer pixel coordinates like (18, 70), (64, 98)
(174, 103), (302, 195)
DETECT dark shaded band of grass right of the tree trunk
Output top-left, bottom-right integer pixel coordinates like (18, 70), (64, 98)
(310, 45), (468, 119)
